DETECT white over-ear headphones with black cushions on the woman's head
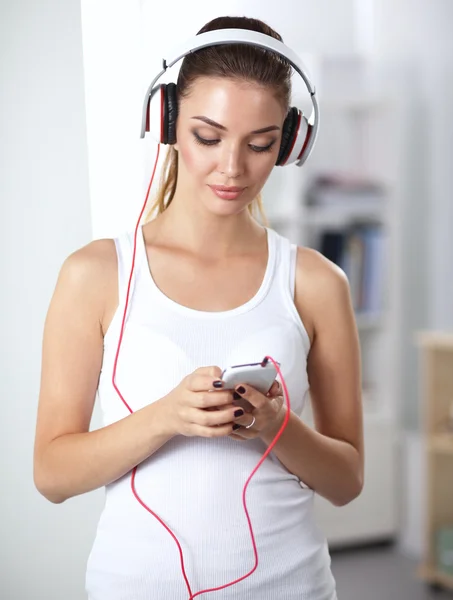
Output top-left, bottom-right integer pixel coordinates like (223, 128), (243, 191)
(140, 29), (319, 167)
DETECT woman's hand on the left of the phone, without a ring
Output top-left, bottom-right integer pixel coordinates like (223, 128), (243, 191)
(162, 367), (241, 438)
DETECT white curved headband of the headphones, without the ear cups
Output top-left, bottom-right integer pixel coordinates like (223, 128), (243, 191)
(140, 29), (319, 165)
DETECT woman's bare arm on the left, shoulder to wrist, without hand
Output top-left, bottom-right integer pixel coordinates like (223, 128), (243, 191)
(34, 240), (175, 502)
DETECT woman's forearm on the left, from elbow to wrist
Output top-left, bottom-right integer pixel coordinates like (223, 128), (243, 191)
(35, 400), (172, 503)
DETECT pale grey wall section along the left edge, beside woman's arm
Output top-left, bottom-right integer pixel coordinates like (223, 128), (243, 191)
(0, 0), (102, 600)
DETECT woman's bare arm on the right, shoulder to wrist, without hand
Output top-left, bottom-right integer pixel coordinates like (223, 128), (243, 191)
(264, 249), (364, 506)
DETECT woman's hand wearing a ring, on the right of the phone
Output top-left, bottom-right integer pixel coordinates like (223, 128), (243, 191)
(228, 381), (286, 442)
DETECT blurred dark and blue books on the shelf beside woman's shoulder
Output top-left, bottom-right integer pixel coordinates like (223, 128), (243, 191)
(318, 224), (386, 315)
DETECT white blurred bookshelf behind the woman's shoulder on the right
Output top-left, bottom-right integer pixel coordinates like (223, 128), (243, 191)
(263, 55), (403, 547)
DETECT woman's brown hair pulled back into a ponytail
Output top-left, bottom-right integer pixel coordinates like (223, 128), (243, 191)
(146, 17), (291, 224)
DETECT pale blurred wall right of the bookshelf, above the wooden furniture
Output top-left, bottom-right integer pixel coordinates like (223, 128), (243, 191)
(374, 0), (453, 430)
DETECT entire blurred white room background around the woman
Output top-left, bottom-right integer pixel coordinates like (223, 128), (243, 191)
(0, 0), (453, 600)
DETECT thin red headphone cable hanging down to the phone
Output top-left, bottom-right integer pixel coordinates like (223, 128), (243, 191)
(112, 143), (292, 600)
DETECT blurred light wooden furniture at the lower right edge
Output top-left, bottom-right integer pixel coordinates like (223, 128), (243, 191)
(416, 332), (453, 589)
